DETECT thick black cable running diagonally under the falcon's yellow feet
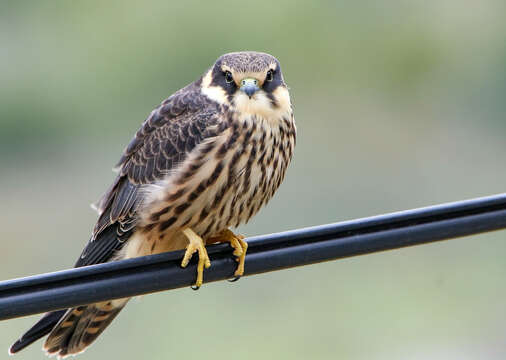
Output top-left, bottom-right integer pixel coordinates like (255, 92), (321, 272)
(0, 193), (506, 320)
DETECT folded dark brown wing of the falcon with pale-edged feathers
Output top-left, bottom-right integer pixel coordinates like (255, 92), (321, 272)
(76, 81), (220, 267)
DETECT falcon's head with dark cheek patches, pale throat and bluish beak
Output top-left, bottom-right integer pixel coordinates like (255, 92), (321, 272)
(202, 51), (291, 118)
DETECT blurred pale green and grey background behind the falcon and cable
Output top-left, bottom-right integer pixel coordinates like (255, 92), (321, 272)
(0, 0), (506, 360)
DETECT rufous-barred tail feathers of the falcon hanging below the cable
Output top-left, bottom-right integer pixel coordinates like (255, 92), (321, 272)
(43, 299), (128, 357)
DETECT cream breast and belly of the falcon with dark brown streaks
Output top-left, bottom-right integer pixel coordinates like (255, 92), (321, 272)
(140, 114), (295, 242)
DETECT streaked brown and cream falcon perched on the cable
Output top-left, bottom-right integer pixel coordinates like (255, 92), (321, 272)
(9, 51), (296, 358)
